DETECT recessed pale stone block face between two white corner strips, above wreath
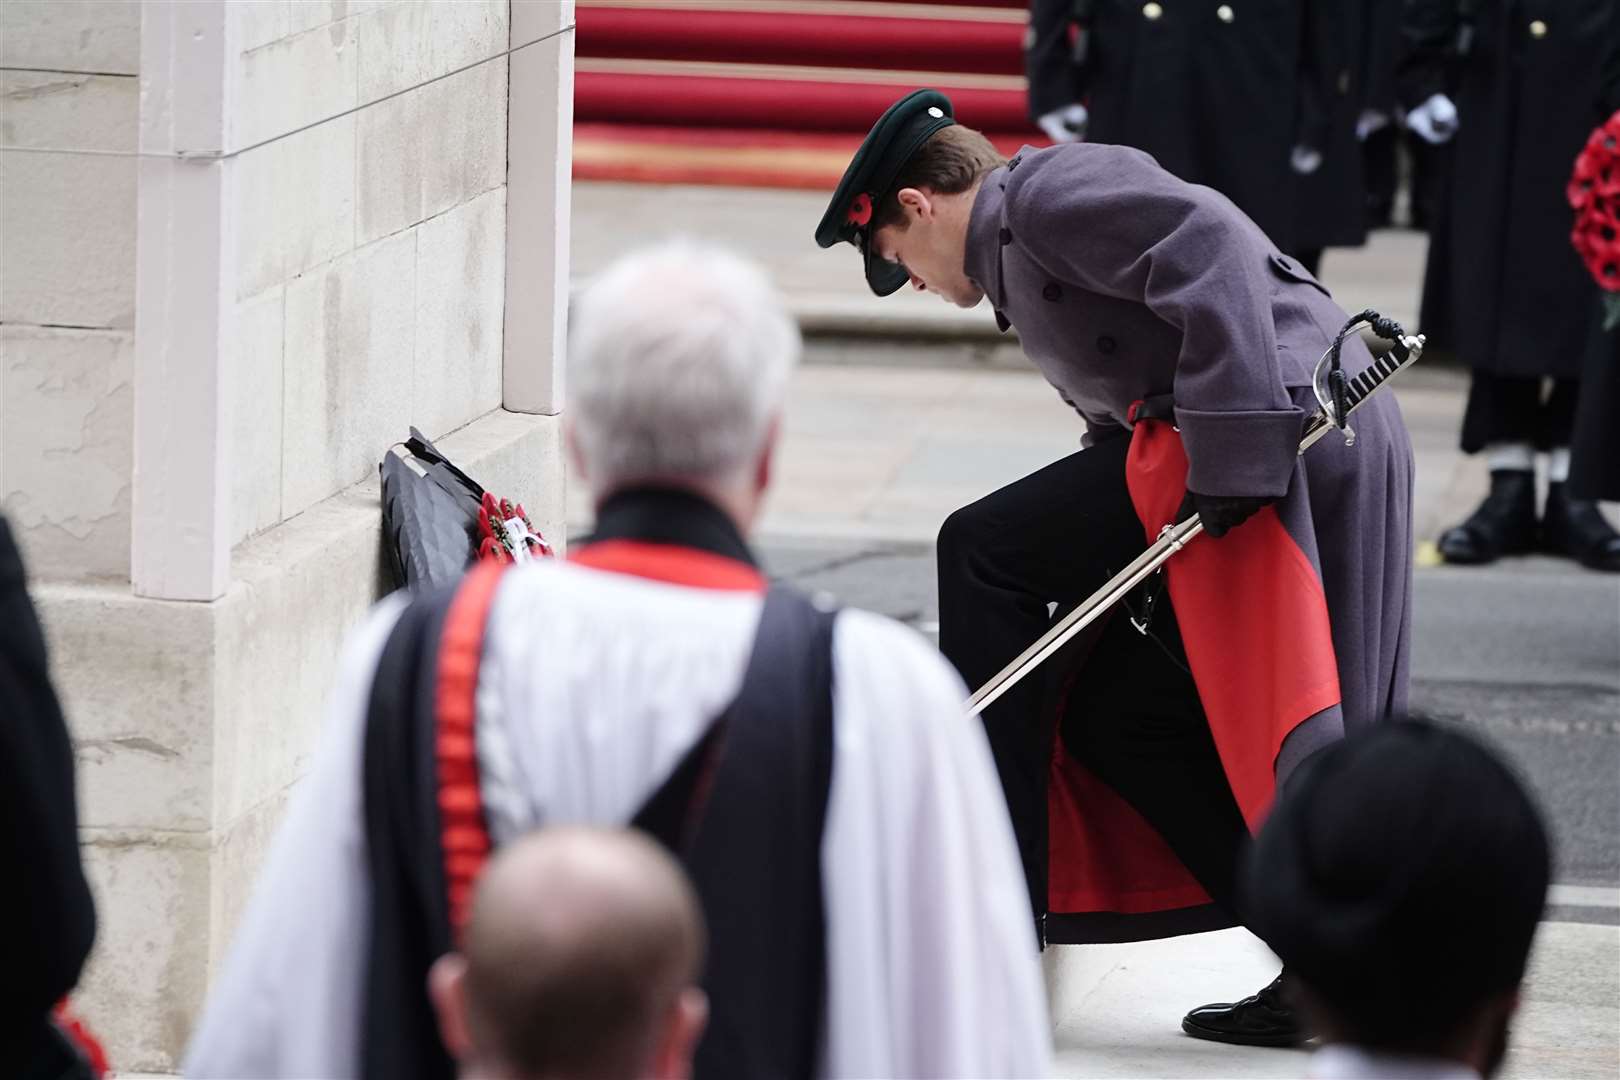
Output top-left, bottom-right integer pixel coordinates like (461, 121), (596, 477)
(228, 0), (509, 541)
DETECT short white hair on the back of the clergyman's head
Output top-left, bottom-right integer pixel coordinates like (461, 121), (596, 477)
(569, 240), (800, 499)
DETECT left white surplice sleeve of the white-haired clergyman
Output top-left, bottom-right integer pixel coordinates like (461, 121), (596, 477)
(185, 593), (405, 1080)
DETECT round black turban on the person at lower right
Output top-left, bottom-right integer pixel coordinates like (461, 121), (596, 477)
(1239, 721), (1552, 1043)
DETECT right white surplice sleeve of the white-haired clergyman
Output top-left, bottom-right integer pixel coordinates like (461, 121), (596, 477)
(821, 610), (1051, 1080)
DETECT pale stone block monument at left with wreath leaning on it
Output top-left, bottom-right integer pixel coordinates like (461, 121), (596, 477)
(0, 0), (572, 1072)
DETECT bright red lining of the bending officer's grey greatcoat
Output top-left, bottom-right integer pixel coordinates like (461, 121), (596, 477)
(1047, 419), (1340, 915)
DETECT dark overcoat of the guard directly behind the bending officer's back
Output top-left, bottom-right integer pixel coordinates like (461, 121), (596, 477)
(1025, 0), (1328, 251)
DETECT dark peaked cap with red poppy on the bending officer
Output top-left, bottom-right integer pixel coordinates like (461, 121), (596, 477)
(815, 91), (956, 296)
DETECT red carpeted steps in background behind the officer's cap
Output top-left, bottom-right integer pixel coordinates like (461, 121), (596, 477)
(573, 0), (1042, 189)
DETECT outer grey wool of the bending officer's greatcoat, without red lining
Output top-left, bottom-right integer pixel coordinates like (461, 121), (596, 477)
(966, 142), (1413, 793)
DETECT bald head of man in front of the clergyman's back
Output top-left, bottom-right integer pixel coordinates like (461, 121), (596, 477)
(434, 827), (705, 1080)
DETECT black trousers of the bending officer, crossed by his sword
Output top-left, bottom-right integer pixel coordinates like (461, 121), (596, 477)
(940, 437), (1249, 915)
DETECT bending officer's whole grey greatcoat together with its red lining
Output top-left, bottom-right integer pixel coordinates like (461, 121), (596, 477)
(966, 142), (1413, 939)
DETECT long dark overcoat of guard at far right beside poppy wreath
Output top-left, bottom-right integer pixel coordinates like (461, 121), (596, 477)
(1400, 0), (1617, 379)
